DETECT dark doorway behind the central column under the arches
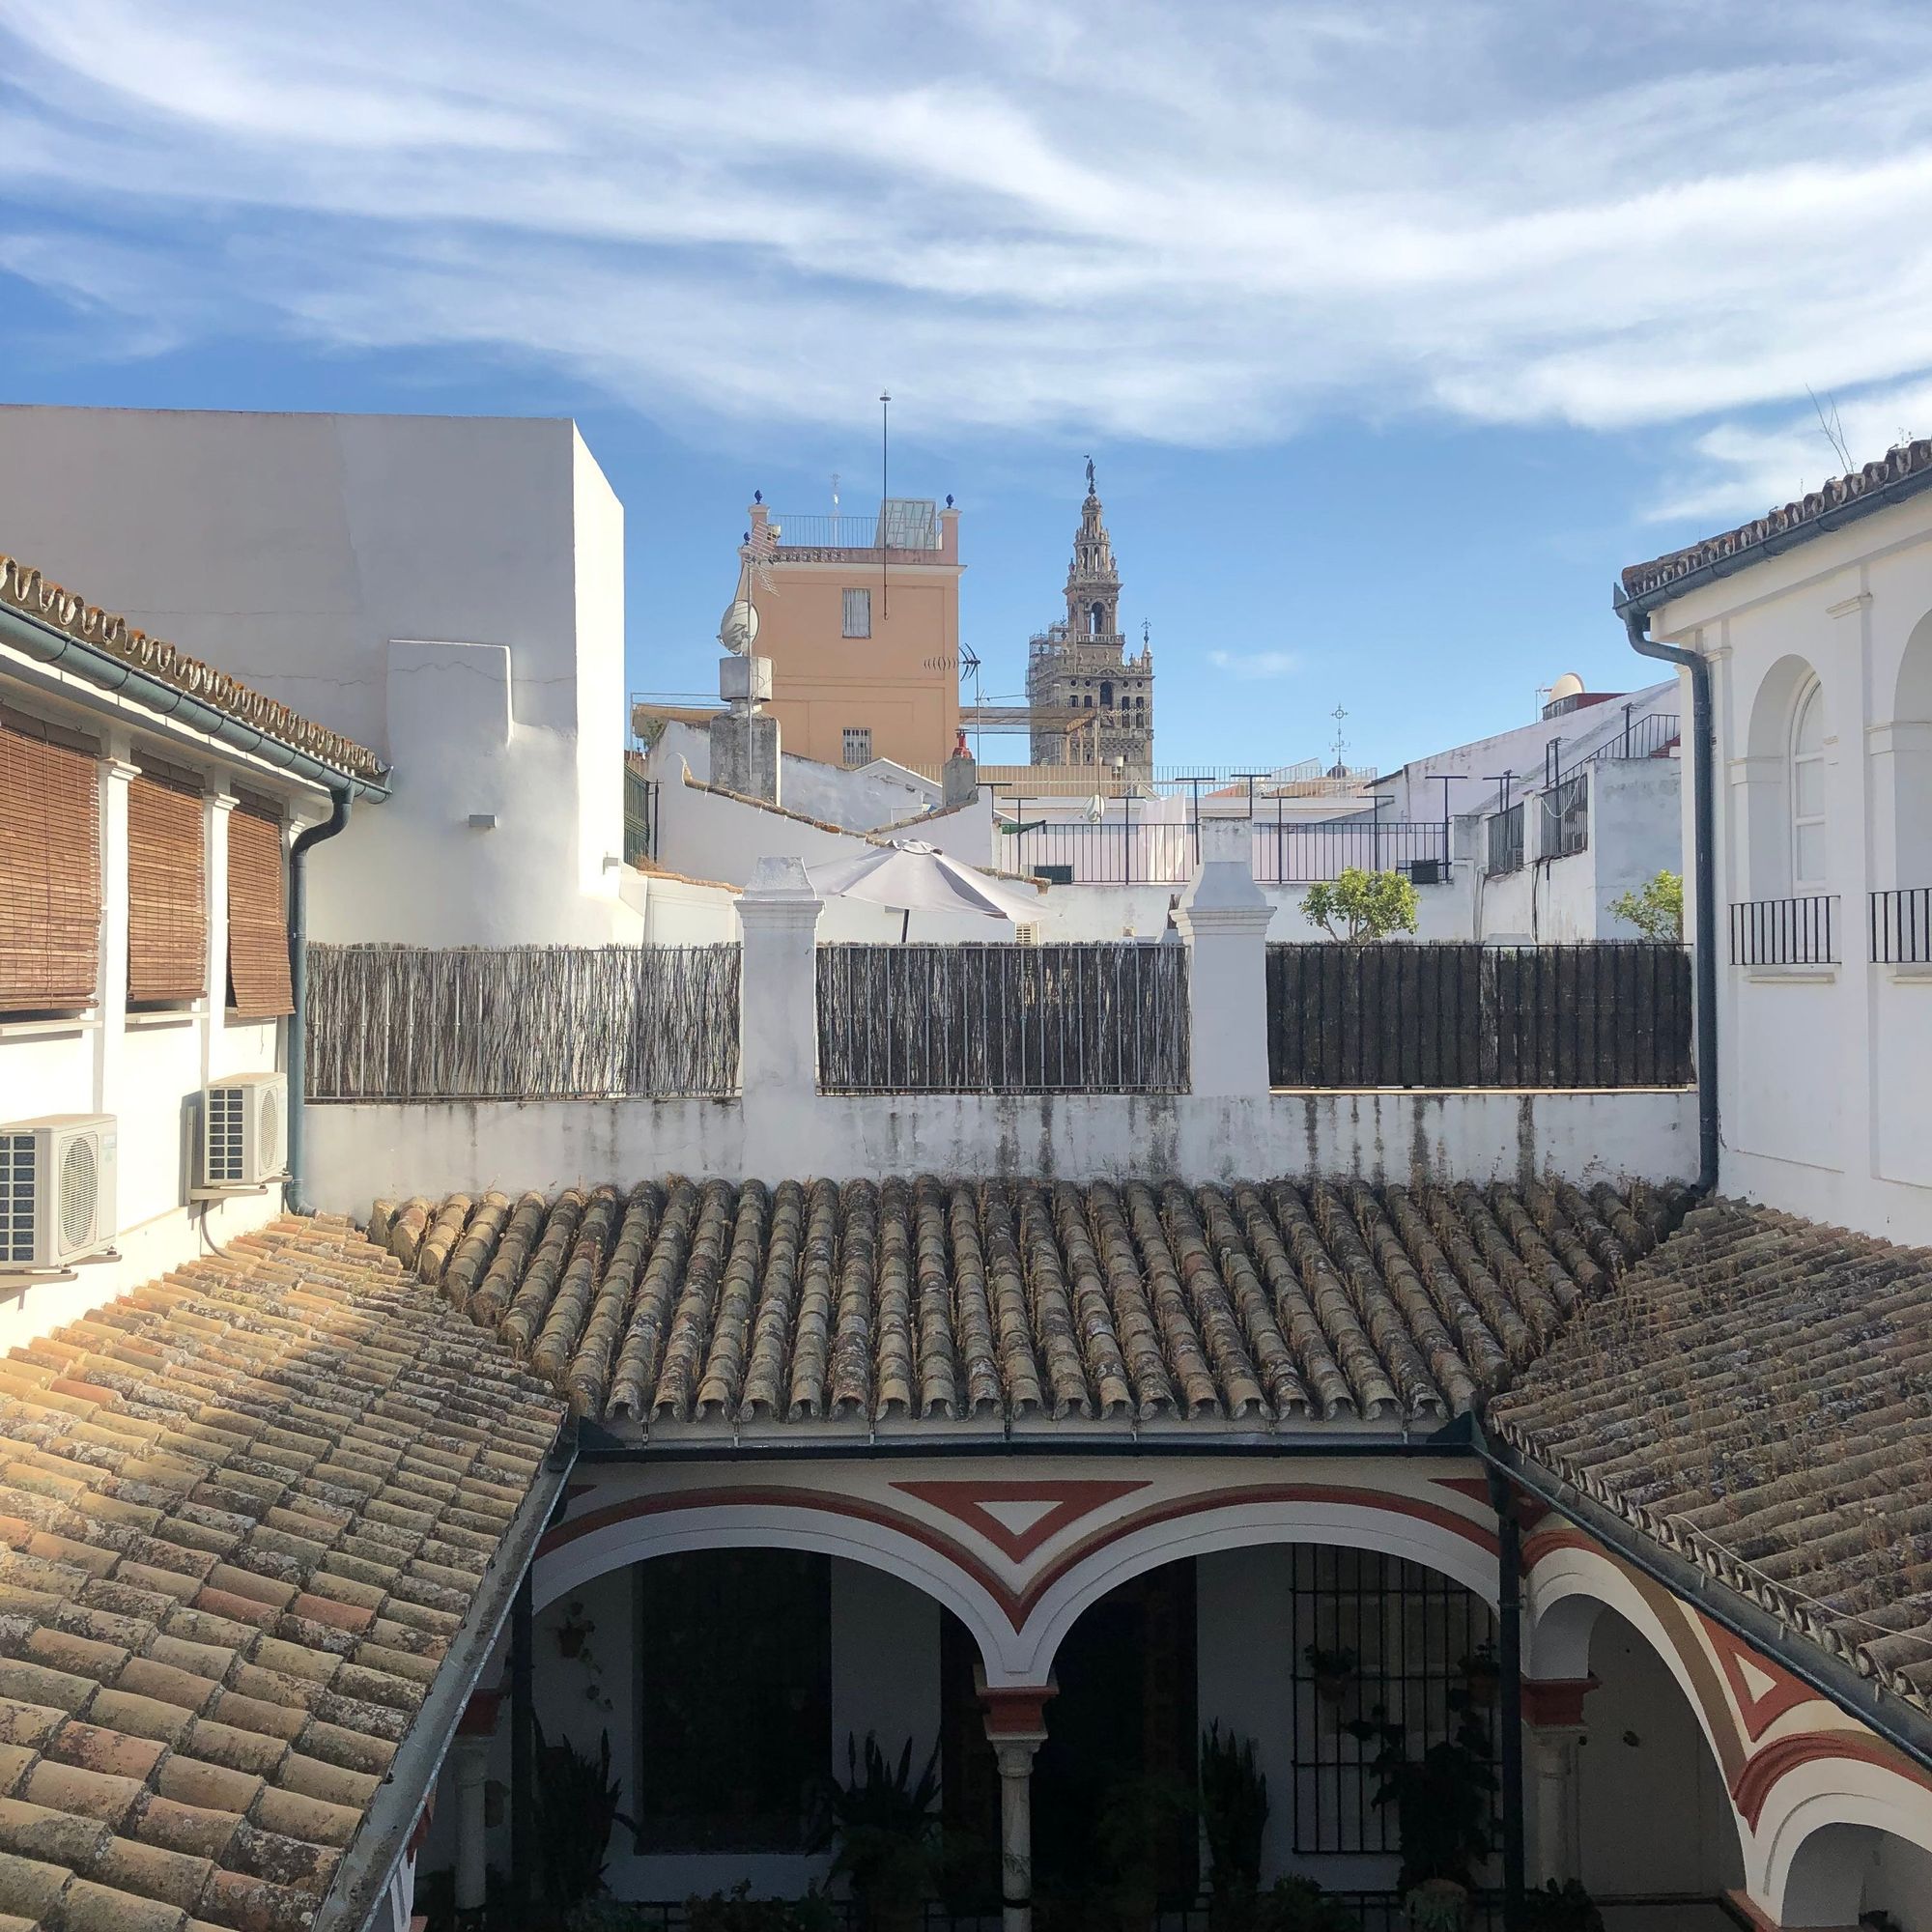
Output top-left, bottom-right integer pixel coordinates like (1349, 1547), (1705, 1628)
(941, 1561), (1200, 1932)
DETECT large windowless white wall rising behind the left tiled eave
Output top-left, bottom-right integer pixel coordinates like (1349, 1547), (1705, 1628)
(0, 408), (639, 945)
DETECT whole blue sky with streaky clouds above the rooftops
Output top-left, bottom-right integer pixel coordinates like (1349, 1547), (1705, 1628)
(0, 0), (1932, 765)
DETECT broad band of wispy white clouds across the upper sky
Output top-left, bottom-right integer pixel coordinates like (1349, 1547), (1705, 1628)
(0, 0), (1932, 475)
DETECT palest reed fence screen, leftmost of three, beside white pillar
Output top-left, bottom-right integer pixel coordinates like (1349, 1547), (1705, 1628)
(307, 945), (738, 1101)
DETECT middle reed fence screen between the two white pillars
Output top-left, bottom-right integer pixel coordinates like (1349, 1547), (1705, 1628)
(817, 941), (1188, 1094)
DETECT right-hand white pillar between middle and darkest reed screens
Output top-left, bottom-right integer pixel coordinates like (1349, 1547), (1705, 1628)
(1175, 819), (1275, 1094)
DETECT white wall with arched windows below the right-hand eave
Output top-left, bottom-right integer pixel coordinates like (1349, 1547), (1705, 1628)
(1652, 479), (1932, 1242)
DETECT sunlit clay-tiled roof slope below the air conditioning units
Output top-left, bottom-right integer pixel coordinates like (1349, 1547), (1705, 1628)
(0, 1221), (562, 1932)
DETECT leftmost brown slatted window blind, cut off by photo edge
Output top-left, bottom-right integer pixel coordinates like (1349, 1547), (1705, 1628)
(0, 713), (100, 1012)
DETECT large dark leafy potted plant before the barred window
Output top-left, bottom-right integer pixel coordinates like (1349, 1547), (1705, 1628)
(1347, 1692), (1497, 1932)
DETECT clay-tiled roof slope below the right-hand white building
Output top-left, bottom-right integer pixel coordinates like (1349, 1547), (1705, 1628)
(1490, 1202), (1932, 1708)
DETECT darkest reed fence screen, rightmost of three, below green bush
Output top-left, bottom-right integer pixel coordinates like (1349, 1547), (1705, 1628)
(1267, 939), (1692, 1088)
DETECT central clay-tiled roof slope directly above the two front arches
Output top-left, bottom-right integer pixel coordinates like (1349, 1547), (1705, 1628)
(369, 1177), (1677, 1430)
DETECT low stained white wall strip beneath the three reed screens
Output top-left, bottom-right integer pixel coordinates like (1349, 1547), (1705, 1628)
(309, 1088), (1696, 1215)
